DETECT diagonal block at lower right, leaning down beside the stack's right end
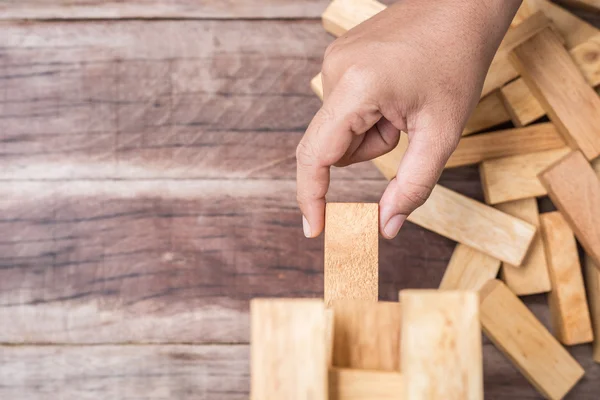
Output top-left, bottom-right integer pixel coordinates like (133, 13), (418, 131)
(480, 280), (585, 399)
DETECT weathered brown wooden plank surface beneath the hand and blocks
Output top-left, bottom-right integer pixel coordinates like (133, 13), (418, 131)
(0, 0), (600, 400)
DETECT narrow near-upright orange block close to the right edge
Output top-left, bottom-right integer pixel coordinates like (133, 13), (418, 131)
(540, 211), (594, 345)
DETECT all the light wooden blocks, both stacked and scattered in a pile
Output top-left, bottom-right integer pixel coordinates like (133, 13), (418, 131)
(251, 0), (600, 400)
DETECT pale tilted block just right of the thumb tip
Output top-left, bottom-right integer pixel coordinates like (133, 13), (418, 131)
(408, 185), (536, 265)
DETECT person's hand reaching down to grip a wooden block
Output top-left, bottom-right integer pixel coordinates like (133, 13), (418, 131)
(296, 0), (521, 239)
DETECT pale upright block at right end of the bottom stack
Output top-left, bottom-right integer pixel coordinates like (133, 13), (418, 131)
(400, 290), (483, 400)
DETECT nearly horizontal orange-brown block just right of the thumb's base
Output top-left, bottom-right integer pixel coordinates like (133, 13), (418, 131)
(446, 123), (565, 168)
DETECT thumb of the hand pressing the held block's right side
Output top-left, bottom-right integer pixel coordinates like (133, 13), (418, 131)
(379, 117), (460, 239)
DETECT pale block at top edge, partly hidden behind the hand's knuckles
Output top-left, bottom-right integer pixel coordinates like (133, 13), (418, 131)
(322, 0), (386, 36)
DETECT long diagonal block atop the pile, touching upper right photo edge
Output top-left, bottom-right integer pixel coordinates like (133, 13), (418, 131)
(511, 28), (600, 160)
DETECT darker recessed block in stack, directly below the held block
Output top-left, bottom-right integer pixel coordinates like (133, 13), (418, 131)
(331, 300), (402, 371)
